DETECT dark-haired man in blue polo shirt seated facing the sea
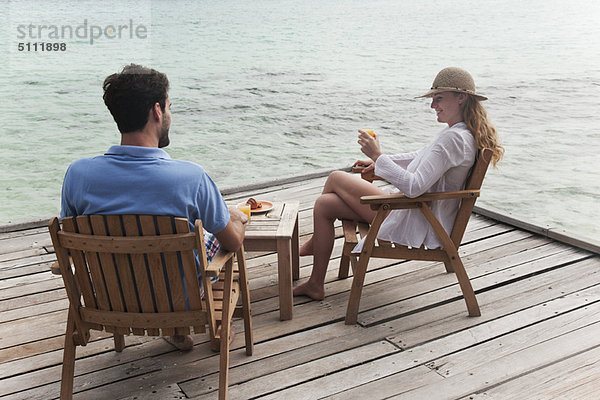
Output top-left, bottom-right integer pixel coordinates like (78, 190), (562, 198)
(61, 64), (248, 350)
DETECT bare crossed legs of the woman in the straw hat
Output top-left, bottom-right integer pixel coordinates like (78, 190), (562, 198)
(294, 172), (385, 300)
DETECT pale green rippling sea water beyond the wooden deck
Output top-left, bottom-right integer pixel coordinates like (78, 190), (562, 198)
(0, 0), (600, 240)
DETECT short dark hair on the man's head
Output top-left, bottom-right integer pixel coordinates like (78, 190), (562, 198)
(102, 64), (169, 133)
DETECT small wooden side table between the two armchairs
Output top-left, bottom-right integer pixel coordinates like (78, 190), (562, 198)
(244, 201), (300, 320)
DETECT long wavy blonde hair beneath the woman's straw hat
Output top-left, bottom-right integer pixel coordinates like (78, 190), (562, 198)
(461, 94), (504, 168)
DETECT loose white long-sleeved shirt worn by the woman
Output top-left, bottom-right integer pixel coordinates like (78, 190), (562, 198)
(353, 122), (477, 253)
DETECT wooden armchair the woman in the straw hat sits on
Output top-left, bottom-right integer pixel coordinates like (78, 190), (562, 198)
(339, 149), (492, 325)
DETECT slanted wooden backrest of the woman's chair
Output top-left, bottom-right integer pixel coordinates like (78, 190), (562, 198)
(450, 149), (492, 248)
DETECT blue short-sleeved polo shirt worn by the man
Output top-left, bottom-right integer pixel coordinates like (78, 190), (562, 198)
(61, 146), (229, 233)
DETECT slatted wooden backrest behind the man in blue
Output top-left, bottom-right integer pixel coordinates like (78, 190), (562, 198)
(50, 215), (212, 335)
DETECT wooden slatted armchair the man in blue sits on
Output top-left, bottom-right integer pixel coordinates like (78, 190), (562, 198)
(49, 215), (253, 399)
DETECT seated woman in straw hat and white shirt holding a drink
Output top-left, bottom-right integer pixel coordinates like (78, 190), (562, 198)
(294, 67), (504, 300)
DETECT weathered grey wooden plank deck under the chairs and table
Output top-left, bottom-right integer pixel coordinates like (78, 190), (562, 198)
(0, 172), (600, 399)
